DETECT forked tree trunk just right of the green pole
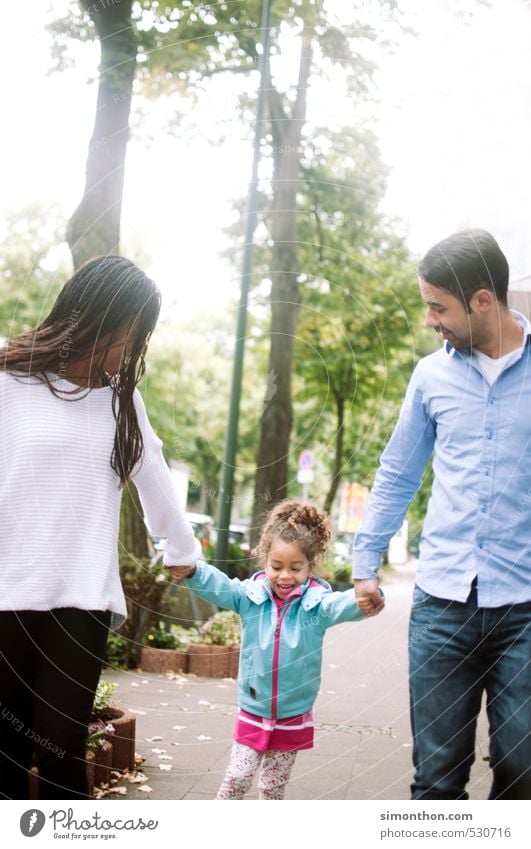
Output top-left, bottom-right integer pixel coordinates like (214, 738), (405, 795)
(252, 30), (312, 545)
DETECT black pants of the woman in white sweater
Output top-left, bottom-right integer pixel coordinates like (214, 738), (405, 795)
(0, 608), (111, 799)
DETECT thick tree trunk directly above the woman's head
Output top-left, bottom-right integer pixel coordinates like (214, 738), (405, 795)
(66, 0), (137, 269)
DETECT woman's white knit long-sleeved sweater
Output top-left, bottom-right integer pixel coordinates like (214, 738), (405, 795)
(0, 372), (201, 628)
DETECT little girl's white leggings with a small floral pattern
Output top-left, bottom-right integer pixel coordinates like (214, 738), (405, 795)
(216, 743), (297, 799)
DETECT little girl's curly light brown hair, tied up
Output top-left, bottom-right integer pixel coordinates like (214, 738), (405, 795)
(253, 499), (331, 566)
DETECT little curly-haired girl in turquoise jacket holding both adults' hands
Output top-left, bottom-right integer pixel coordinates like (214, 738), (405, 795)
(171, 501), (376, 799)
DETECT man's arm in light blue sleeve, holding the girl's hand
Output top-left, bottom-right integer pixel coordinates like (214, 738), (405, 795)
(352, 364), (436, 615)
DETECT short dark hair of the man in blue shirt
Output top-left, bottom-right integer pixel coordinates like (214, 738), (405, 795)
(419, 230), (509, 307)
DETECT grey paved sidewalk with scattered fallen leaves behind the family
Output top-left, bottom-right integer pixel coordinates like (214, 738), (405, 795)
(102, 569), (490, 800)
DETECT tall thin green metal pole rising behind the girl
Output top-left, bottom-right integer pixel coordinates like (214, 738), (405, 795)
(215, 0), (271, 567)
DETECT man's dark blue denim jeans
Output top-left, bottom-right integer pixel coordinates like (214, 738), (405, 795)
(409, 586), (531, 799)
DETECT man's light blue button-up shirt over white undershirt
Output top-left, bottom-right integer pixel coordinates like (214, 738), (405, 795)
(353, 313), (531, 607)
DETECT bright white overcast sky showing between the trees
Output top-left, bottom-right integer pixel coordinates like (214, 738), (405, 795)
(0, 0), (531, 324)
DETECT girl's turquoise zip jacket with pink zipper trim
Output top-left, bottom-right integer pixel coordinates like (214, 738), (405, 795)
(183, 561), (365, 719)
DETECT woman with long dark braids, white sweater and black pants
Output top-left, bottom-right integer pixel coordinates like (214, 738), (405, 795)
(0, 256), (201, 799)
